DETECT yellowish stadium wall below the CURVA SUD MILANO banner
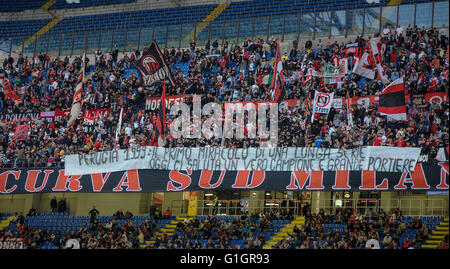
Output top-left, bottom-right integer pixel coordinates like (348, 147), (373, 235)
(0, 191), (449, 216)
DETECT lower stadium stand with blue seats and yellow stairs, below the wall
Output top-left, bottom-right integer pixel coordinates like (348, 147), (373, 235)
(0, 206), (448, 249)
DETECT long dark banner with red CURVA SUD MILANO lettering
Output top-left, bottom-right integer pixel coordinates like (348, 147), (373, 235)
(0, 161), (449, 194)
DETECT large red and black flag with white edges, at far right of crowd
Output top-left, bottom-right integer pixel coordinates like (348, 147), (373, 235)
(378, 77), (406, 120)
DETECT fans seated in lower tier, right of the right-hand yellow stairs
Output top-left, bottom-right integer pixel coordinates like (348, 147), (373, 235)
(276, 206), (431, 249)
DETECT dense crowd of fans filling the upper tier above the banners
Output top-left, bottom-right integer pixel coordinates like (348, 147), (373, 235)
(0, 27), (449, 167)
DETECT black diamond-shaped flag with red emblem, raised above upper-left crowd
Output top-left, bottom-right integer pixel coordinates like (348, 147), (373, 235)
(135, 41), (175, 86)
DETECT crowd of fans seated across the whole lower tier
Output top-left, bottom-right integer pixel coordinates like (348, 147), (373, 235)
(0, 207), (448, 249)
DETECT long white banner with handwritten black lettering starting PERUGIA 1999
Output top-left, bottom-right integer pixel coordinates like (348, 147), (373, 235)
(65, 146), (420, 175)
